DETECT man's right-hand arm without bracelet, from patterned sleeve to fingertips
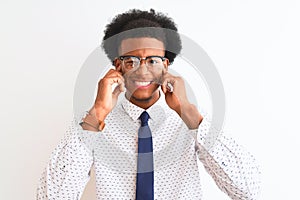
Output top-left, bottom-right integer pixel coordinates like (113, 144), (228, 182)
(161, 73), (260, 199)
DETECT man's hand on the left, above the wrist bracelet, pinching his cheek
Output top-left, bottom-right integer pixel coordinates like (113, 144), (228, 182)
(92, 69), (125, 121)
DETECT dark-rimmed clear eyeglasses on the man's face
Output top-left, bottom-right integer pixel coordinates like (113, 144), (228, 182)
(118, 56), (167, 71)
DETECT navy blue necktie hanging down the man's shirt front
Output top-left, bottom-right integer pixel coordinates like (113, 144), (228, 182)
(136, 111), (154, 200)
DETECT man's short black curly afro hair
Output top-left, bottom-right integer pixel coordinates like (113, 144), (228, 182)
(102, 9), (182, 64)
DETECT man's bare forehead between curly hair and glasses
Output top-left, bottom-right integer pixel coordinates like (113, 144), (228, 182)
(119, 37), (165, 55)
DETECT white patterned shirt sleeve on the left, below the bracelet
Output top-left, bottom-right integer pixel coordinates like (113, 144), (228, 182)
(37, 113), (95, 200)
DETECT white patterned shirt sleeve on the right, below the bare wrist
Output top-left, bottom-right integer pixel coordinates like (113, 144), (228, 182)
(195, 115), (260, 200)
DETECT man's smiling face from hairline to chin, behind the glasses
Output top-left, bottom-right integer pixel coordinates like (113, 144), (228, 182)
(115, 37), (169, 107)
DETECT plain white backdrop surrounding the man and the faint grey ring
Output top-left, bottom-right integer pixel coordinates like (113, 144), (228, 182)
(0, 0), (300, 200)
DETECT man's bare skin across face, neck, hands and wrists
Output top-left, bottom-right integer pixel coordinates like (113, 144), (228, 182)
(82, 37), (203, 131)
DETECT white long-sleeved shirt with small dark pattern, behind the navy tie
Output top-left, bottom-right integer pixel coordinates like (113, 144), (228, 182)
(37, 96), (260, 200)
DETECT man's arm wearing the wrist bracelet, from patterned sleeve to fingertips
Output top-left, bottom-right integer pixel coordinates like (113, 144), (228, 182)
(37, 67), (125, 200)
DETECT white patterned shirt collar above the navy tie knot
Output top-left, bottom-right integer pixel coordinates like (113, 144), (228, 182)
(121, 91), (169, 121)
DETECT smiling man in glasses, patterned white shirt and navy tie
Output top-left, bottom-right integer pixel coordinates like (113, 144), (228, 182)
(37, 10), (259, 200)
